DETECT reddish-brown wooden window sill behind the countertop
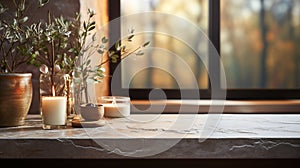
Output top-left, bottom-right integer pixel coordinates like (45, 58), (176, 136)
(131, 100), (300, 114)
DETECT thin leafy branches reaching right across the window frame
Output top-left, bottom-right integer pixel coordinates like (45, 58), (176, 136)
(74, 9), (150, 102)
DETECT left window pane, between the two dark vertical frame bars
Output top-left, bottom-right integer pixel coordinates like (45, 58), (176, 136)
(121, 0), (208, 89)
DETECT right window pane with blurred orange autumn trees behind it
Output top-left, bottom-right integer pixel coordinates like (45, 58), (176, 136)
(221, 0), (300, 89)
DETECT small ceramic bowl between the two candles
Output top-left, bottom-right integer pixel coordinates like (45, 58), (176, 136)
(80, 104), (104, 121)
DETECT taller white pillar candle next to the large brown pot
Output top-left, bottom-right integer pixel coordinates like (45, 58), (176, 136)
(41, 96), (67, 127)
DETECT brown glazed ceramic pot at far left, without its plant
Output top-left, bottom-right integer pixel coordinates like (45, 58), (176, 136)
(0, 73), (32, 127)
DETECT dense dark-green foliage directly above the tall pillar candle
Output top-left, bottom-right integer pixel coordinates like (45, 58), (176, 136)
(27, 11), (75, 74)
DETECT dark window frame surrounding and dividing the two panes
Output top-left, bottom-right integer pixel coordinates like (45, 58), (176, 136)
(108, 0), (300, 100)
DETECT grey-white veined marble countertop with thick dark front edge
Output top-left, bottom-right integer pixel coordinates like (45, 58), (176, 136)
(0, 114), (300, 158)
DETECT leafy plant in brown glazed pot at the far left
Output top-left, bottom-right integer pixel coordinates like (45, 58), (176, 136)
(0, 0), (47, 127)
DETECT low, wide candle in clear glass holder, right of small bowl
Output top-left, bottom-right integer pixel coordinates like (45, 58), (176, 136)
(99, 96), (130, 118)
